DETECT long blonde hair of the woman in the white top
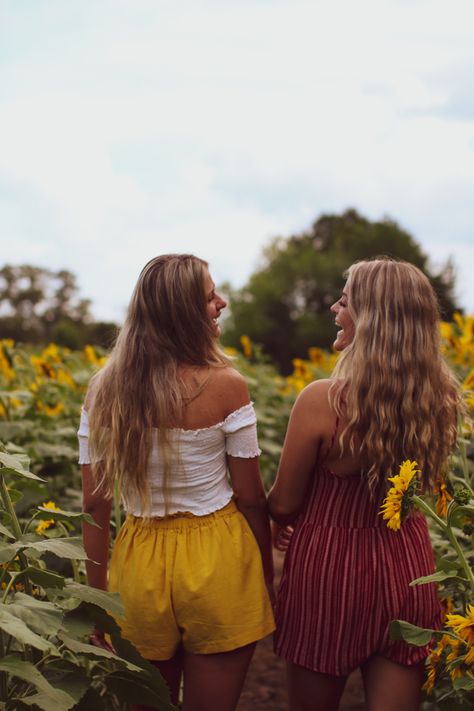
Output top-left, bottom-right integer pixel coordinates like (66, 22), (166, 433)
(86, 254), (230, 512)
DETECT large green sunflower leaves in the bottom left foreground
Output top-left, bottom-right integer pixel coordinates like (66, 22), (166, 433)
(0, 448), (175, 711)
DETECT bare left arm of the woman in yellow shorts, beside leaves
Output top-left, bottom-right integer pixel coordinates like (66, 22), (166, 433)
(81, 464), (112, 590)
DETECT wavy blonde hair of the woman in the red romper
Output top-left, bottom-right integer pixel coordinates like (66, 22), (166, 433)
(329, 257), (462, 492)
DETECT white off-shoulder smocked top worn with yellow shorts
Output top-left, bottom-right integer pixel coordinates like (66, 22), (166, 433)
(77, 403), (261, 516)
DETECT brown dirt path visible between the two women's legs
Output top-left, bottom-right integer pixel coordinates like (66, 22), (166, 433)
(237, 552), (365, 711)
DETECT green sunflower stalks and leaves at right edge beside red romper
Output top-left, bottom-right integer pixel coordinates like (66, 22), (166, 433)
(390, 444), (474, 711)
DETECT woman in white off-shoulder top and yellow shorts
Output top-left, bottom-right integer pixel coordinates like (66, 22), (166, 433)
(79, 254), (274, 711)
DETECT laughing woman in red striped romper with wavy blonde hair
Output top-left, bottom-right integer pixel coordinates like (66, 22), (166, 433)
(269, 258), (461, 711)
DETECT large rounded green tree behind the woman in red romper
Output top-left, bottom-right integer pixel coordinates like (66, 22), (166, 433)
(223, 209), (462, 372)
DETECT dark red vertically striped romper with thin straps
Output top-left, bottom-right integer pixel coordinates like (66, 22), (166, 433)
(275, 448), (441, 676)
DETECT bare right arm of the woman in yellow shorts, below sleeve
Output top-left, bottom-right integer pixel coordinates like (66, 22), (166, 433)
(227, 456), (273, 588)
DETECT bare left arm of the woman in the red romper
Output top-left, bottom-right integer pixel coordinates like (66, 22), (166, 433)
(268, 381), (328, 526)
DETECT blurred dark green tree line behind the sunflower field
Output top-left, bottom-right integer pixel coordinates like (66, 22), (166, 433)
(0, 209), (459, 373)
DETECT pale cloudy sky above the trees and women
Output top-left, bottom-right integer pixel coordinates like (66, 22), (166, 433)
(0, 0), (474, 321)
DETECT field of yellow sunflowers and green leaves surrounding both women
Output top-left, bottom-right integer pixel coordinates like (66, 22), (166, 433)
(0, 315), (474, 711)
